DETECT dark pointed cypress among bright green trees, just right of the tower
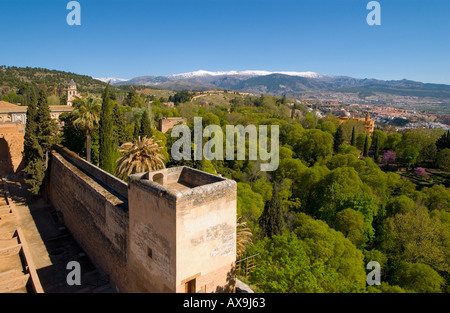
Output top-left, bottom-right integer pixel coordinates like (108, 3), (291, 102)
(259, 184), (284, 238)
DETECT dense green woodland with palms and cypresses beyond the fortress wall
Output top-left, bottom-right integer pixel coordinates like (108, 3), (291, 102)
(18, 81), (450, 293)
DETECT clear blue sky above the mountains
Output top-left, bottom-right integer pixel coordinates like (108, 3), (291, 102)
(0, 0), (450, 84)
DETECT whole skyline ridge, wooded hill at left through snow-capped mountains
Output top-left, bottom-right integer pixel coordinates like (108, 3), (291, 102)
(0, 66), (450, 104)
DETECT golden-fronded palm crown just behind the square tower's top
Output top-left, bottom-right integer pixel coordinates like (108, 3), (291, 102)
(116, 137), (166, 179)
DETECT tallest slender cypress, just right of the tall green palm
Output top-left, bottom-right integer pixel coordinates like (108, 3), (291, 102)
(99, 83), (118, 174)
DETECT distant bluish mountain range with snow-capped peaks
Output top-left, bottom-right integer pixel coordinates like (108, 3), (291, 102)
(97, 70), (450, 100)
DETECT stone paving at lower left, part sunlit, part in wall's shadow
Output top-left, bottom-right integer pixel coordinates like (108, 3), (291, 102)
(0, 179), (114, 293)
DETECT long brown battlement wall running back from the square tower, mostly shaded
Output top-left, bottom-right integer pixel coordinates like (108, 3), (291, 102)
(46, 149), (131, 291)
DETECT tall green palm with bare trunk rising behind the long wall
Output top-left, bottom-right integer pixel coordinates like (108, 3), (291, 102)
(73, 96), (101, 162)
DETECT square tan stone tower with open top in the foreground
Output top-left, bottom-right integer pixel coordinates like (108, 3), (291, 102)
(128, 167), (236, 293)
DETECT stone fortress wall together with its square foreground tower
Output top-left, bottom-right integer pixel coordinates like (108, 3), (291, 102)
(46, 147), (236, 292)
